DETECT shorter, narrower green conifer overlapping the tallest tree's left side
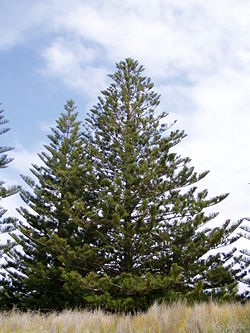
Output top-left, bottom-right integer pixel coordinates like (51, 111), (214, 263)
(2, 100), (98, 310)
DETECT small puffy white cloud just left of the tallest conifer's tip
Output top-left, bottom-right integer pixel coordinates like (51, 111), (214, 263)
(42, 38), (107, 98)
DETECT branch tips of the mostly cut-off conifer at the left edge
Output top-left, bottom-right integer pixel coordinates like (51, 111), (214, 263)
(0, 106), (18, 239)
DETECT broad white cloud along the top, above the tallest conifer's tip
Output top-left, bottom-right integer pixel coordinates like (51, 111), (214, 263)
(39, 1), (249, 78)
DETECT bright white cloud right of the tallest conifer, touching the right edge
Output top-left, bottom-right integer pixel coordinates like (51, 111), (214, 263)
(170, 69), (250, 218)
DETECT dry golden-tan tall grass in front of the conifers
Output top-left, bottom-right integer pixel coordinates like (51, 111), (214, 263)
(0, 303), (250, 333)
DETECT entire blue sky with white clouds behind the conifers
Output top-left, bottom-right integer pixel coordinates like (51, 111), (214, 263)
(0, 0), (250, 246)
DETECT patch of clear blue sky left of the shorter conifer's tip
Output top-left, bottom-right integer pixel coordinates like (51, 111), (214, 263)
(0, 36), (87, 149)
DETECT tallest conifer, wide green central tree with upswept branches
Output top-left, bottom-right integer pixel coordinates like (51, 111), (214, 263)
(59, 58), (241, 311)
